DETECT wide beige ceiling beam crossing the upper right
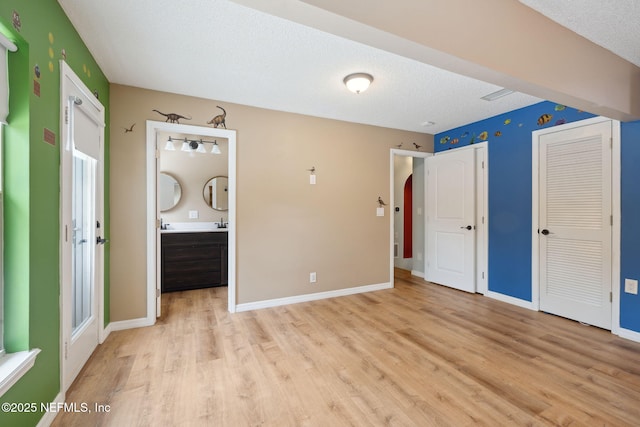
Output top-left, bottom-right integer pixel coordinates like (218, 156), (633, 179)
(234, 0), (640, 121)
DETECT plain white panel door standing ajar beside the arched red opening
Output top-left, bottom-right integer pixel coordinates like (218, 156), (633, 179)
(425, 149), (476, 292)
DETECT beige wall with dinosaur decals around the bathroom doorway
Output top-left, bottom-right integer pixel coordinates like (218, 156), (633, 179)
(111, 84), (433, 321)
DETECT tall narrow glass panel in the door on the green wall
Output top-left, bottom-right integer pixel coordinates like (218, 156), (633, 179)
(71, 152), (96, 336)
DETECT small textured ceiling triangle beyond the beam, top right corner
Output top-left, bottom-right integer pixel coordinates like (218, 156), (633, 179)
(520, 0), (640, 67)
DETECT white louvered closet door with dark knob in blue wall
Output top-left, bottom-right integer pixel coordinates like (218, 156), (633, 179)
(538, 122), (612, 329)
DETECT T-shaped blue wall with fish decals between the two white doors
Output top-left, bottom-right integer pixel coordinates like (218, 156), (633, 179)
(434, 101), (594, 301)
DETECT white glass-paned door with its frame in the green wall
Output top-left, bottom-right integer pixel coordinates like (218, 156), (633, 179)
(61, 64), (106, 391)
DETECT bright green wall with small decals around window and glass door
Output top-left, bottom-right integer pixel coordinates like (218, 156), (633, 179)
(0, 0), (109, 426)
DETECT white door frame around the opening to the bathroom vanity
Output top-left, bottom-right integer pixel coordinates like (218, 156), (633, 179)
(145, 120), (237, 325)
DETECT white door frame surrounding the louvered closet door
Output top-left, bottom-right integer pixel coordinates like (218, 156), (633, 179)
(531, 117), (622, 335)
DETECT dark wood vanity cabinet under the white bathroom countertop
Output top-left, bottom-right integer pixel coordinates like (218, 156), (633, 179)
(161, 232), (227, 292)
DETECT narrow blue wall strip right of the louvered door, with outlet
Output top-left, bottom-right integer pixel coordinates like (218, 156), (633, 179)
(620, 121), (640, 332)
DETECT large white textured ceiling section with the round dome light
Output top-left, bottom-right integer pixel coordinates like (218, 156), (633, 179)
(59, 0), (637, 134)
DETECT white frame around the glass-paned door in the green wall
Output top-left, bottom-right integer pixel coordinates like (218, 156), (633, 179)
(59, 60), (108, 394)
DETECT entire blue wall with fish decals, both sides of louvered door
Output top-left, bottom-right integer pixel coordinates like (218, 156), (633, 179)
(434, 101), (640, 332)
